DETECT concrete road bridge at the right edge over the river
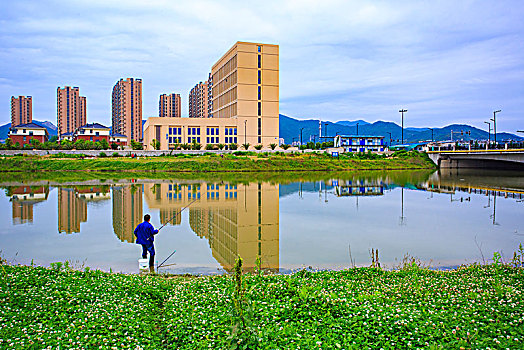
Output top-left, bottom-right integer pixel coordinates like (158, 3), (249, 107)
(427, 149), (524, 170)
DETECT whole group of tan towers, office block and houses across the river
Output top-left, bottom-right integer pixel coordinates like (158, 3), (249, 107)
(9, 42), (280, 150)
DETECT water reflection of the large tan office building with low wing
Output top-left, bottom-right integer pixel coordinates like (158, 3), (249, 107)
(144, 182), (279, 271)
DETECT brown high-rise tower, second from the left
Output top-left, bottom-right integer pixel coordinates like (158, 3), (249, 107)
(56, 86), (86, 139)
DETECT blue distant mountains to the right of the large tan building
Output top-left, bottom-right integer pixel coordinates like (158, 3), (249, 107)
(279, 114), (524, 144)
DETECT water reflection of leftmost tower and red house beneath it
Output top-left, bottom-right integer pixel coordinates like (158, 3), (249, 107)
(7, 186), (49, 225)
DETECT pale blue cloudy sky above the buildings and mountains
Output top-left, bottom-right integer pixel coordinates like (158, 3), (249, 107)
(0, 0), (524, 133)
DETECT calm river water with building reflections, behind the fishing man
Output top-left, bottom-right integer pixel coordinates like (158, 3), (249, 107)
(0, 170), (524, 274)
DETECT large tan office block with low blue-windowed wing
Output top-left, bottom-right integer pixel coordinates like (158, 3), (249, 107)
(144, 42), (279, 150)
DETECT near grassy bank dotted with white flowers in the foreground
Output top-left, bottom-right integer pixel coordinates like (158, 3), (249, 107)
(0, 264), (524, 349)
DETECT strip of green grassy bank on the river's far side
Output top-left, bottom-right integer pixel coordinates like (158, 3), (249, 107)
(0, 152), (435, 172)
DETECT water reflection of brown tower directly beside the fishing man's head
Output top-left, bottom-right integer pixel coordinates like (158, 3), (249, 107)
(112, 184), (143, 243)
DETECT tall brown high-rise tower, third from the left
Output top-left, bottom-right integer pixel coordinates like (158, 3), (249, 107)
(112, 78), (142, 145)
